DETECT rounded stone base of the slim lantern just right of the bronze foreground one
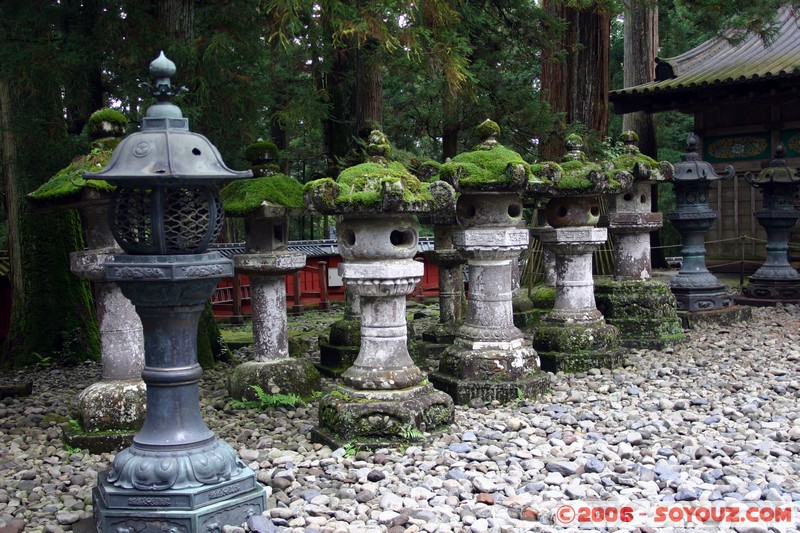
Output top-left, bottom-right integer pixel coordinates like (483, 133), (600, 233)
(228, 357), (319, 400)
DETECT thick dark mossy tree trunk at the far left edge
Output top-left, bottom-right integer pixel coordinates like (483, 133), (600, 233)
(0, 0), (100, 366)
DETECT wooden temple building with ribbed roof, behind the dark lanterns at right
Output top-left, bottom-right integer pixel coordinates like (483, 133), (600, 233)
(610, 7), (800, 260)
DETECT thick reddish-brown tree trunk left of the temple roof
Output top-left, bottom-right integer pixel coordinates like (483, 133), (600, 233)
(540, 0), (611, 159)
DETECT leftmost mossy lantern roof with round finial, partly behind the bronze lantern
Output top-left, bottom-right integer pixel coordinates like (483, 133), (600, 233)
(28, 108), (128, 208)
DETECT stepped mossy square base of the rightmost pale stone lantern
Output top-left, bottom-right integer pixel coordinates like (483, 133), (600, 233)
(594, 279), (683, 350)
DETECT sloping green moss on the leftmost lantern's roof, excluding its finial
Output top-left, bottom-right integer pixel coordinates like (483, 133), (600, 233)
(28, 145), (119, 204)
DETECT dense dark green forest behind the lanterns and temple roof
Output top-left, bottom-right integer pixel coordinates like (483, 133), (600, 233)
(0, 0), (786, 367)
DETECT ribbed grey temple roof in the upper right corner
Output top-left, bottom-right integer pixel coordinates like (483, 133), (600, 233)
(609, 7), (800, 114)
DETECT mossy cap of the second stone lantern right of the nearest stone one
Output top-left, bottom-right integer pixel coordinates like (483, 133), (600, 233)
(528, 134), (633, 198)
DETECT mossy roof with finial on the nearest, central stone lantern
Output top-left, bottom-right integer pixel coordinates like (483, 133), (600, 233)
(303, 130), (455, 215)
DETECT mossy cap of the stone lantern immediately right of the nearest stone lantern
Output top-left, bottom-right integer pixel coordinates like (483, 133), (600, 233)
(439, 119), (542, 193)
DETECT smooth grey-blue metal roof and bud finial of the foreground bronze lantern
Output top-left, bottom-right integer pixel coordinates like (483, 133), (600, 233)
(84, 52), (252, 187)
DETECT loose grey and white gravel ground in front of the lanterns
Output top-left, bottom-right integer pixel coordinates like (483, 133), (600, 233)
(0, 306), (800, 533)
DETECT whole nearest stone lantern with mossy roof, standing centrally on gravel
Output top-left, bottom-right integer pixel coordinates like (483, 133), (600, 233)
(305, 131), (455, 447)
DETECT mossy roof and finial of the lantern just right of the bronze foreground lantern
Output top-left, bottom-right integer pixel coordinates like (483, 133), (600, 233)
(219, 141), (303, 217)
